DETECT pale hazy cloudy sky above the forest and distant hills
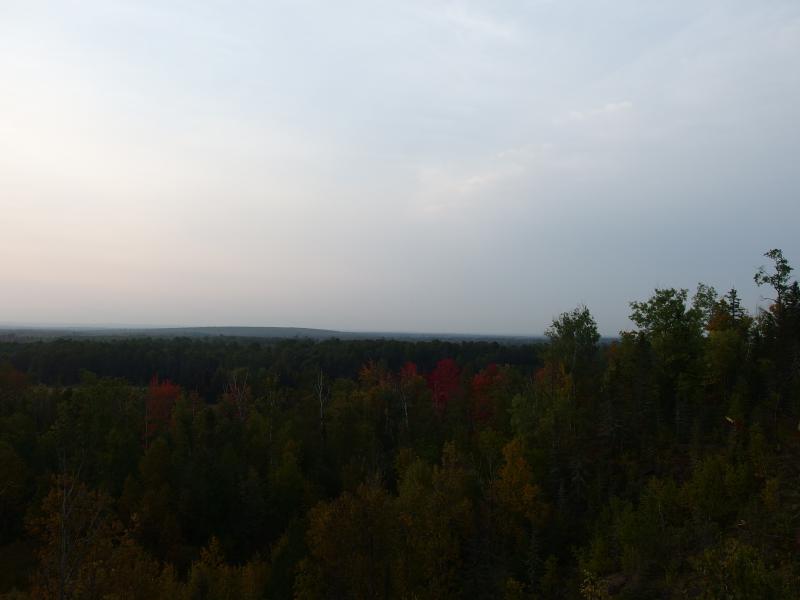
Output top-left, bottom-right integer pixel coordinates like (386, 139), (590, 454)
(0, 0), (800, 335)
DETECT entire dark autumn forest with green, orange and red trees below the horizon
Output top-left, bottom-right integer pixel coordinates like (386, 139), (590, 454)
(0, 250), (800, 600)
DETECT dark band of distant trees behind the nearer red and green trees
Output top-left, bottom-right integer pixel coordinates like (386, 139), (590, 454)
(0, 337), (541, 402)
